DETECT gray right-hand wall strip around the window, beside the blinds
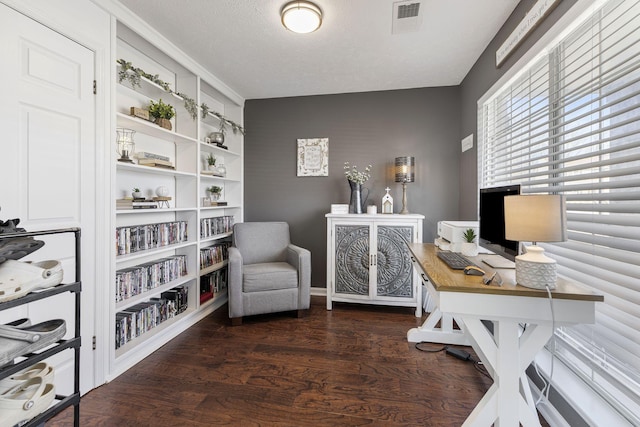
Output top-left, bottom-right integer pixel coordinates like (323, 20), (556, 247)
(459, 0), (577, 220)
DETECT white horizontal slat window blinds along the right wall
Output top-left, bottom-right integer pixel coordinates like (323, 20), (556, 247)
(478, 0), (640, 425)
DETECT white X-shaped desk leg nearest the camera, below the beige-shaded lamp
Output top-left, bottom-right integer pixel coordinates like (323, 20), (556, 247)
(462, 316), (553, 427)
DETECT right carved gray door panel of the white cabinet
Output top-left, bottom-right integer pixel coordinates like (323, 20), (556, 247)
(376, 225), (414, 298)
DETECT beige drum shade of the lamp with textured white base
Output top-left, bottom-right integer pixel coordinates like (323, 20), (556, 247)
(504, 194), (567, 242)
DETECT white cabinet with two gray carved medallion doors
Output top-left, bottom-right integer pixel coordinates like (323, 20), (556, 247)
(326, 214), (424, 317)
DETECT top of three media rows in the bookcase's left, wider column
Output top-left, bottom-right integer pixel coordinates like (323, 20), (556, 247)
(116, 221), (188, 255)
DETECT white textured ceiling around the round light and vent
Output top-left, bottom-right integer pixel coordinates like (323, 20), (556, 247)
(120, 0), (518, 99)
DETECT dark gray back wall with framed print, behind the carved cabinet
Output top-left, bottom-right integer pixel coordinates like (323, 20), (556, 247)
(244, 87), (461, 287)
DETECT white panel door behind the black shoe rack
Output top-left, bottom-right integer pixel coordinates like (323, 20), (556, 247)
(0, 5), (96, 393)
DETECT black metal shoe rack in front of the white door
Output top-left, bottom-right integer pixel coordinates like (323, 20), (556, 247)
(0, 228), (82, 427)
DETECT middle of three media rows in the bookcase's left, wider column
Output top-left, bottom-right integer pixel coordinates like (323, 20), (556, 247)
(116, 255), (187, 302)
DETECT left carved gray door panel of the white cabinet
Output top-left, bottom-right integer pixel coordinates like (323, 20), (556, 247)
(335, 225), (370, 295)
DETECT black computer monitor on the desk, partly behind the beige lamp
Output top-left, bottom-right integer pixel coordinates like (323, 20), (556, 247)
(478, 185), (520, 261)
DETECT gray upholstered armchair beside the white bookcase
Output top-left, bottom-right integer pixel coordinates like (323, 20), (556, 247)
(229, 222), (311, 325)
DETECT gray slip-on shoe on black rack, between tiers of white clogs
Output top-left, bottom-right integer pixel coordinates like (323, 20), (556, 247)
(0, 319), (67, 366)
